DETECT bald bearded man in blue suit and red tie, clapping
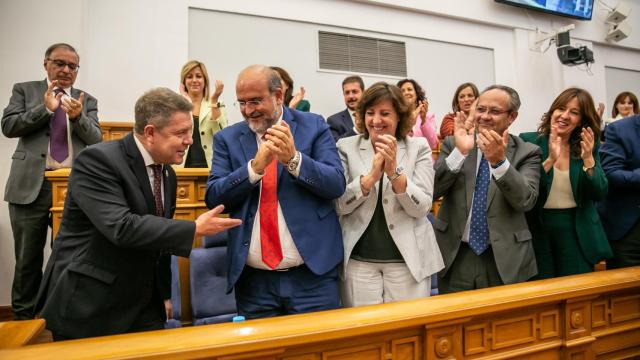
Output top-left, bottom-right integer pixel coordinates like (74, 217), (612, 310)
(205, 65), (345, 319)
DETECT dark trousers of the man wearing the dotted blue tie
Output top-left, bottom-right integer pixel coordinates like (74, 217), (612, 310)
(438, 242), (504, 294)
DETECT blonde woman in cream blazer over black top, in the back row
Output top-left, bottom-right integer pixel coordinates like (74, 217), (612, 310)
(180, 60), (227, 168)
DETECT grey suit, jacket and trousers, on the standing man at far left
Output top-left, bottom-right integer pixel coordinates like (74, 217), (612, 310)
(2, 80), (102, 319)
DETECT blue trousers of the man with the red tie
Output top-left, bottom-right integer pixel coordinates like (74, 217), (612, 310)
(235, 265), (340, 319)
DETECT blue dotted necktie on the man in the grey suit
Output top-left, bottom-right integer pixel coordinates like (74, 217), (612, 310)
(469, 155), (490, 255)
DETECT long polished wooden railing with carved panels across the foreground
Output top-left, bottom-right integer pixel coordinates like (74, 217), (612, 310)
(0, 267), (640, 360)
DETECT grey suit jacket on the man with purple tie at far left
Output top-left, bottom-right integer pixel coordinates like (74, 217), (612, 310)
(2, 80), (102, 204)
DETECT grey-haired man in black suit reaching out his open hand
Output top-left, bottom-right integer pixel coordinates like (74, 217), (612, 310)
(36, 88), (241, 340)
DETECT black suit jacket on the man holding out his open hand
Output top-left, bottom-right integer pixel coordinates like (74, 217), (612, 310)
(36, 134), (195, 338)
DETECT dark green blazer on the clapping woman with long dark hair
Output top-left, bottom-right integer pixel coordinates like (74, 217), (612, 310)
(520, 132), (613, 276)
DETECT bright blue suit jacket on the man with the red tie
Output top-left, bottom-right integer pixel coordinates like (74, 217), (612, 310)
(205, 108), (345, 291)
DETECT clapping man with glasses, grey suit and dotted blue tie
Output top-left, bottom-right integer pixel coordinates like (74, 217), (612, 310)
(434, 85), (541, 293)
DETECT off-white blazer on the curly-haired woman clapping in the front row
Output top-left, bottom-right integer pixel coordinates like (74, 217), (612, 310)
(336, 135), (444, 282)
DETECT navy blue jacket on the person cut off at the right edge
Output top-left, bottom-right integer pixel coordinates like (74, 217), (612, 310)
(598, 115), (640, 241)
